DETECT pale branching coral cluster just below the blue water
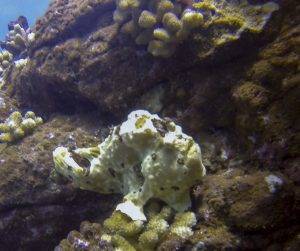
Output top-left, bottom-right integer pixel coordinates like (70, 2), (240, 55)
(0, 18), (35, 58)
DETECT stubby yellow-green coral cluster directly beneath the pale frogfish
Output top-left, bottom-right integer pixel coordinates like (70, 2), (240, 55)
(56, 201), (197, 251)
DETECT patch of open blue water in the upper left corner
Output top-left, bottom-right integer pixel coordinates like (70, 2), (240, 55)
(0, 0), (50, 40)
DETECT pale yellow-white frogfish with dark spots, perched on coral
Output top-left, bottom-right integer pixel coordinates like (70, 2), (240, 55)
(53, 110), (205, 220)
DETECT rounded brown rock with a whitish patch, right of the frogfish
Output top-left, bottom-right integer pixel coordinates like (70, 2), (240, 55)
(203, 170), (296, 232)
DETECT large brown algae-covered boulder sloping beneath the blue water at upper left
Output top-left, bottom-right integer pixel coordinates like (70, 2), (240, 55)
(13, 0), (280, 116)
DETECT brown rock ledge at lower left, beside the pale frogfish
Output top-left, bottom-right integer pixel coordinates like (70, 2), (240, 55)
(0, 113), (117, 250)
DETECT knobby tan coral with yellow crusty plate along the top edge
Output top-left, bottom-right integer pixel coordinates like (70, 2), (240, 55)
(114, 0), (278, 57)
